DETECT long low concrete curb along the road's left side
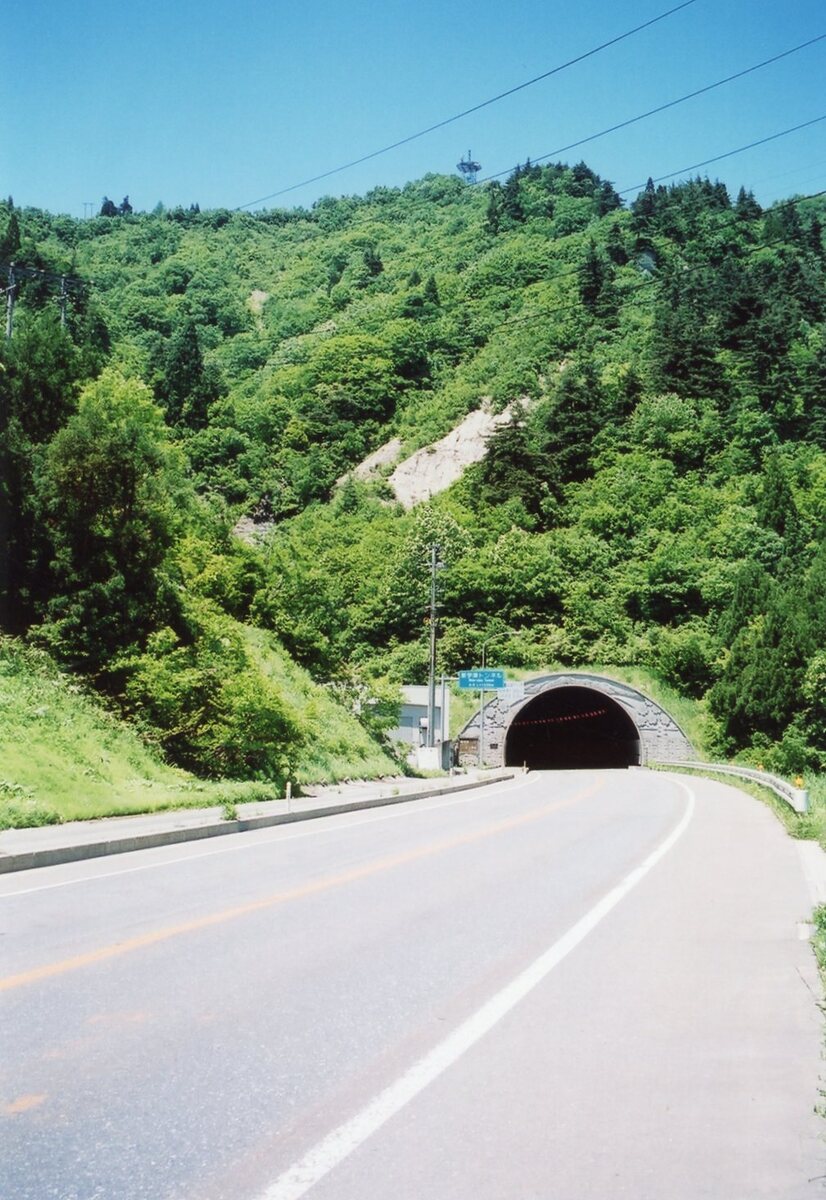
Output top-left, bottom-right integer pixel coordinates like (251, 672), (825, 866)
(0, 770), (516, 875)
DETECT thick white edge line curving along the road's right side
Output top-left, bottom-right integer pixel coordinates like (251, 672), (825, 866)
(256, 780), (695, 1200)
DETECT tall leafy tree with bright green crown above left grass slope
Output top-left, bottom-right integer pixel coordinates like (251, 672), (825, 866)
(37, 371), (180, 673)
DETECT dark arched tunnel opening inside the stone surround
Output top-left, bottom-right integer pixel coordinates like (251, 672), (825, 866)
(504, 688), (641, 770)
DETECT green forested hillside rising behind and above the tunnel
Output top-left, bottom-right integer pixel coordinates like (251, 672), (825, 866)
(0, 163), (826, 796)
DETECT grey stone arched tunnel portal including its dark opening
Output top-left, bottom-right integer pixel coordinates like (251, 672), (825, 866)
(456, 671), (694, 769)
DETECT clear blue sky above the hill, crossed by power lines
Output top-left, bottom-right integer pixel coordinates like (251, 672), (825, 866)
(0, 0), (826, 216)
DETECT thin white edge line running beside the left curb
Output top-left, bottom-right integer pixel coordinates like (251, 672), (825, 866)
(0, 776), (535, 900)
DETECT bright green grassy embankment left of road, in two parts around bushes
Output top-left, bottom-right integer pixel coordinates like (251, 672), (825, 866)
(0, 630), (395, 828)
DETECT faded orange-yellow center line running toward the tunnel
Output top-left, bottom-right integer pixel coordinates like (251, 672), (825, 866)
(0, 782), (603, 991)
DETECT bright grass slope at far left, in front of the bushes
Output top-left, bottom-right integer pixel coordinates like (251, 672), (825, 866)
(0, 638), (274, 829)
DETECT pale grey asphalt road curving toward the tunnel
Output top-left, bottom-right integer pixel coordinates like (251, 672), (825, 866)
(0, 770), (826, 1200)
